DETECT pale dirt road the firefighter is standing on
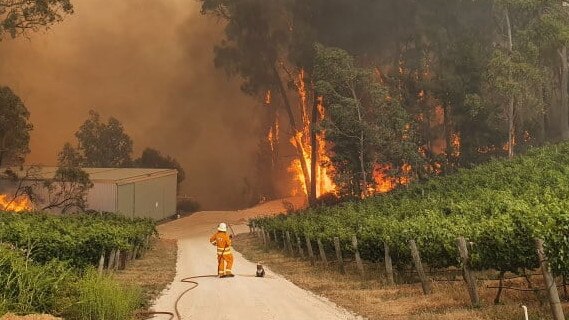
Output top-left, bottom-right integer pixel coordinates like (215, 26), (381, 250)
(152, 202), (361, 320)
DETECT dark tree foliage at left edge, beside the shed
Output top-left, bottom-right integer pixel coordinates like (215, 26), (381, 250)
(0, 87), (33, 166)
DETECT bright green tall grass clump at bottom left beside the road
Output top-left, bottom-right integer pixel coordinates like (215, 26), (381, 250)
(65, 269), (142, 320)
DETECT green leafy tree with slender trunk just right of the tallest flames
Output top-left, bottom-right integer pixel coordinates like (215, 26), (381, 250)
(314, 45), (421, 197)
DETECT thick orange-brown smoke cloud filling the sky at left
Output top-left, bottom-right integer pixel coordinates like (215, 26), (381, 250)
(0, 0), (258, 209)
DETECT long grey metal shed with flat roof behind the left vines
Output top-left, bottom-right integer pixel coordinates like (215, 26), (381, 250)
(0, 167), (178, 220)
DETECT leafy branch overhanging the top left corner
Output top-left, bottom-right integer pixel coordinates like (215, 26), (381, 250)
(0, 0), (73, 39)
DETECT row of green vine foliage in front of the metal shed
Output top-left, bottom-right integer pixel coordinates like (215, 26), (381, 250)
(0, 212), (155, 268)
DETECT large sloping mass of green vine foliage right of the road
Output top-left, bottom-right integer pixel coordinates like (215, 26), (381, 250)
(251, 144), (569, 316)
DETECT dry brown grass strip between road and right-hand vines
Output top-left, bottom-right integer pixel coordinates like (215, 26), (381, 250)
(234, 234), (569, 320)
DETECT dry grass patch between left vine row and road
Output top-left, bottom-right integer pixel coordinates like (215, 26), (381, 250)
(115, 238), (178, 306)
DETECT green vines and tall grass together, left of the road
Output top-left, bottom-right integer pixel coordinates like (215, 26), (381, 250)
(0, 212), (156, 320)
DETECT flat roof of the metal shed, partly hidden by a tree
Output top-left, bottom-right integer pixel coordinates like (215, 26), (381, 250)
(0, 166), (178, 185)
